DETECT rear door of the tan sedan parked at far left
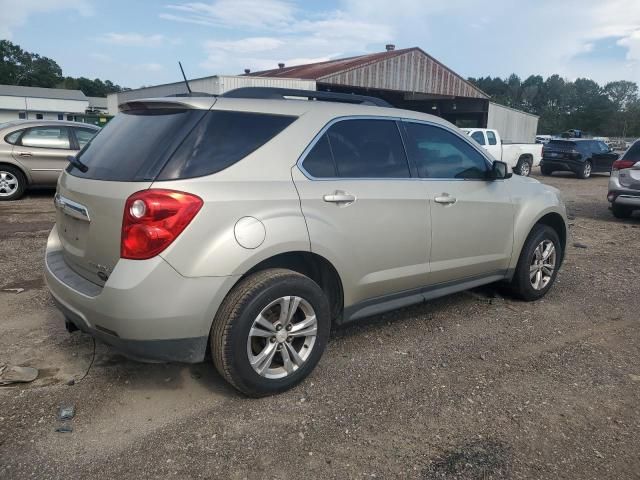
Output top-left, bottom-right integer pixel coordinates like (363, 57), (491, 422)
(13, 125), (76, 185)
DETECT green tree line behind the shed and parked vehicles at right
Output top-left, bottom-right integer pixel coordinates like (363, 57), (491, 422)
(469, 74), (640, 137)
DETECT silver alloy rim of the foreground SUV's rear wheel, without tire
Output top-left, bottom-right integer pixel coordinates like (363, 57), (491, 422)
(247, 296), (318, 379)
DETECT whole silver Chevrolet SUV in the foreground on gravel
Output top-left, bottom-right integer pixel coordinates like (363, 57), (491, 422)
(46, 89), (567, 396)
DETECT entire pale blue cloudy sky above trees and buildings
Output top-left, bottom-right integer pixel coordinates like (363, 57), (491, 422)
(0, 0), (640, 88)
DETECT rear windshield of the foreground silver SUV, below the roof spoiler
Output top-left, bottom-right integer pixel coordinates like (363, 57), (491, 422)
(67, 105), (206, 182)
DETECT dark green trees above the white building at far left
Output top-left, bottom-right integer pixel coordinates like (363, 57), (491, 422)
(0, 40), (123, 97)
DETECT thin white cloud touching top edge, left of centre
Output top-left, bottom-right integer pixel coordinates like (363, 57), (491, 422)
(160, 0), (294, 29)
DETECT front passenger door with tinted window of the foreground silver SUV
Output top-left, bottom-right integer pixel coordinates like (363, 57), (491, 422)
(403, 121), (514, 284)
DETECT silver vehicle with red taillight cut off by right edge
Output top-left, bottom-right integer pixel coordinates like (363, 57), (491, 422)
(607, 140), (640, 218)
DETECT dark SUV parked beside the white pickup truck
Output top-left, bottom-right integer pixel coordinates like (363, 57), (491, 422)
(540, 139), (618, 179)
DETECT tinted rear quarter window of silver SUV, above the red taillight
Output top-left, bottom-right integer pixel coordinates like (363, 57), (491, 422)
(158, 110), (297, 180)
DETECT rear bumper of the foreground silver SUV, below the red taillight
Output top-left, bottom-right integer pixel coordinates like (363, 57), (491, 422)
(45, 227), (237, 363)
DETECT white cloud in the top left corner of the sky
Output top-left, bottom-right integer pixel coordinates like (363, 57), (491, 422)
(0, 0), (93, 39)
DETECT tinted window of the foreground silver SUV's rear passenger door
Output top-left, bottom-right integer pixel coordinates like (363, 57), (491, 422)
(303, 120), (411, 178)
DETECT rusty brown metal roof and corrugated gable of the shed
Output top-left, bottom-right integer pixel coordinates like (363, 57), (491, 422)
(247, 47), (489, 98)
